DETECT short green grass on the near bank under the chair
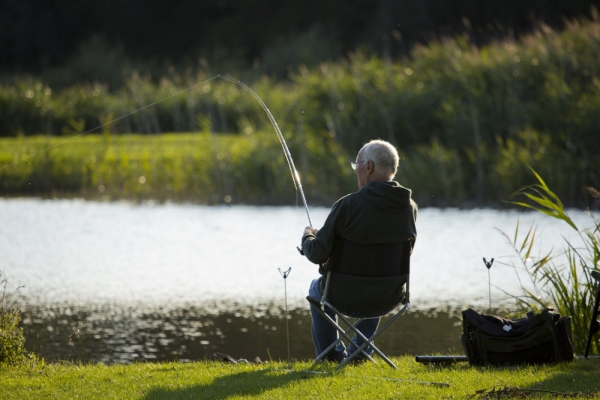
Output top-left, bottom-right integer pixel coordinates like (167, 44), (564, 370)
(0, 356), (600, 399)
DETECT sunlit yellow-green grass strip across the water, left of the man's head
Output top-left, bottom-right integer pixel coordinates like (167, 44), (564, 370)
(0, 132), (356, 205)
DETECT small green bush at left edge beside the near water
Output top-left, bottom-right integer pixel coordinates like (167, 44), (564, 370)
(0, 271), (27, 365)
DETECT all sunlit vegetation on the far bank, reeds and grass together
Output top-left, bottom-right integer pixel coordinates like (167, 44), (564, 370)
(0, 16), (600, 207)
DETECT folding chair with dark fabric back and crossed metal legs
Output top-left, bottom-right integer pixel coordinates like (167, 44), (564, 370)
(306, 238), (414, 369)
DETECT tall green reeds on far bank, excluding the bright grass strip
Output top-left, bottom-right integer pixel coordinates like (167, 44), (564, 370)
(0, 21), (600, 206)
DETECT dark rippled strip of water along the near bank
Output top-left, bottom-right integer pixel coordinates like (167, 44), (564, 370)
(22, 303), (462, 363)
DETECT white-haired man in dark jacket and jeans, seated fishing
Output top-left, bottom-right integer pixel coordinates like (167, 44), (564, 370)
(302, 140), (418, 362)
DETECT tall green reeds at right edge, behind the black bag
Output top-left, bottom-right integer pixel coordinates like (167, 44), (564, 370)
(510, 169), (600, 354)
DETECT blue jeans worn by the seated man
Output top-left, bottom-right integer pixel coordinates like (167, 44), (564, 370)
(308, 277), (379, 361)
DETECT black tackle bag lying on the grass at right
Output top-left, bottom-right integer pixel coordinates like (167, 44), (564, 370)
(460, 308), (573, 366)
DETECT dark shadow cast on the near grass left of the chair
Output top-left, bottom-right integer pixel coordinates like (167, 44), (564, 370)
(145, 369), (315, 400)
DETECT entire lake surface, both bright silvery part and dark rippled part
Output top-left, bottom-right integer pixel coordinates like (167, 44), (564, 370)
(0, 199), (591, 361)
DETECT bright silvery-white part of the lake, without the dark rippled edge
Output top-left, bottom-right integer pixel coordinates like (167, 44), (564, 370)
(0, 199), (590, 306)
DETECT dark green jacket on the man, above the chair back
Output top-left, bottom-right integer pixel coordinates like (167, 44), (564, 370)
(302, 181), (418, 264)
